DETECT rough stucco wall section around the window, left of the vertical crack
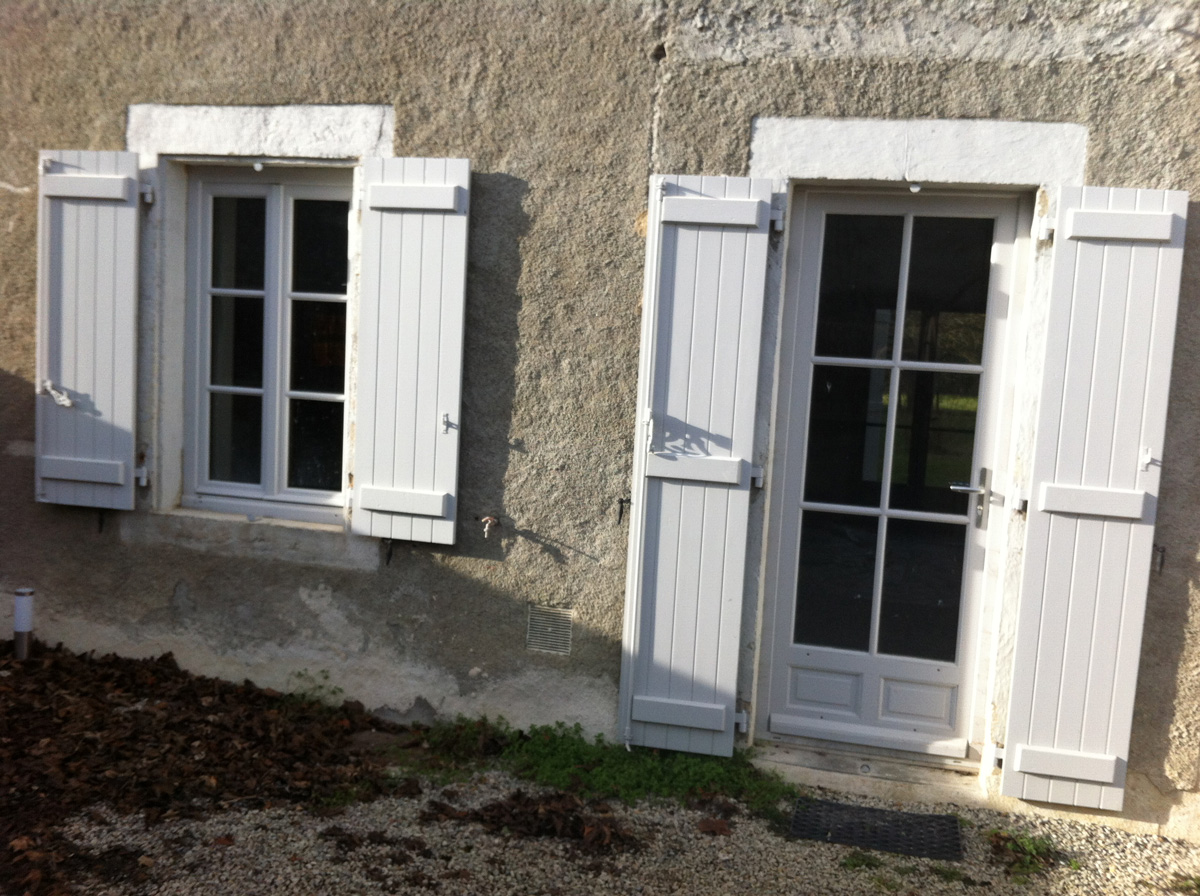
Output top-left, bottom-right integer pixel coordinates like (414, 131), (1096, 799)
(0, 0), (653, 729)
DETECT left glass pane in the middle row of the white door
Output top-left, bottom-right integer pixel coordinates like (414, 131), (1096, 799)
(804, 365), (889, 506)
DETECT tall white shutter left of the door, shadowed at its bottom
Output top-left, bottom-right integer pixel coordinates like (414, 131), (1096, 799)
(620, 176), (772, 756)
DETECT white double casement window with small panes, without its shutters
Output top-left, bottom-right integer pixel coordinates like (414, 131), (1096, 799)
(185, 168), (350, 519)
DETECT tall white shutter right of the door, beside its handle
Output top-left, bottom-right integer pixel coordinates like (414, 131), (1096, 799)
(1002, 187), (1187, 810)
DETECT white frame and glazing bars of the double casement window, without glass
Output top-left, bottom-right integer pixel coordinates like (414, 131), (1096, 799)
(182, 164), (356, 523)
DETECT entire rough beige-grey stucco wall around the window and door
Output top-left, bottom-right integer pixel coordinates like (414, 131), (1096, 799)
(0, 0), (1200, 830)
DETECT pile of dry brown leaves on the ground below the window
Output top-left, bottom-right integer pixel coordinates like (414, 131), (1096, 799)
(0, 644), (403, 896)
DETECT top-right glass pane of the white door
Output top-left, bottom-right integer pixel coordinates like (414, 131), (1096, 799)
(904, 217), (994, 363)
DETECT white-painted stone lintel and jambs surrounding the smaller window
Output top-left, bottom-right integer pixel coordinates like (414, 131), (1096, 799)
(126, 103), (395, 529)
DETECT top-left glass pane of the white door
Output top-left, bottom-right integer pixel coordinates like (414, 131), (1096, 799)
(816, 215), (904, 357)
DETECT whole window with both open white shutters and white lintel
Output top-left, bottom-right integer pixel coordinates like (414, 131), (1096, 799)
(36, 104), (470, 545)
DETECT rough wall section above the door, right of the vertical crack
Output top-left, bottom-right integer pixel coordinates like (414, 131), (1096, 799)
(653, 0), (1200, 815)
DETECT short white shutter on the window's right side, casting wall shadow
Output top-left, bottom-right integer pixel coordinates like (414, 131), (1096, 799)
(350, 158), (470, 545)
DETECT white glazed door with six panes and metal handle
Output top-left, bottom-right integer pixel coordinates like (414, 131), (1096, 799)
(767, 192), (1016, 756)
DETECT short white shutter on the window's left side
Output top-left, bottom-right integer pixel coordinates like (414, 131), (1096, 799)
(36, 151), (138, 510)
